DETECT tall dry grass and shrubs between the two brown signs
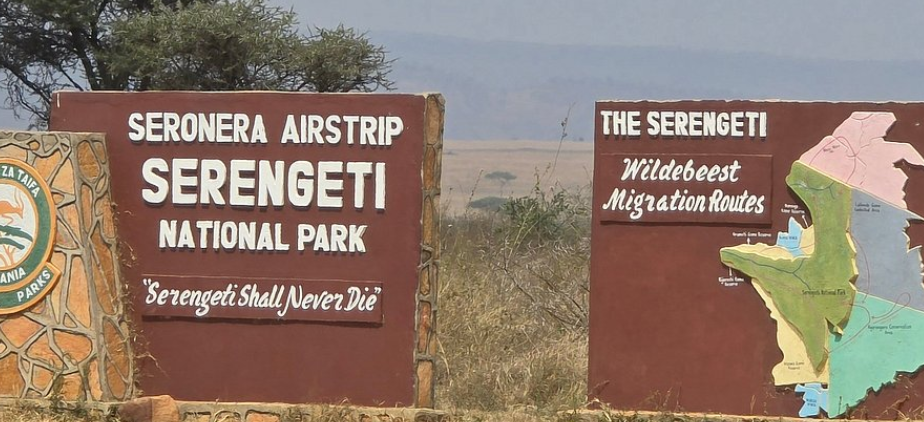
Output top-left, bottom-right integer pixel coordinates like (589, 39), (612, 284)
(438, 178), (590, 411)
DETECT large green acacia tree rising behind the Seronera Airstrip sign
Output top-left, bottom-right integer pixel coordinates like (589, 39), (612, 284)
(0, 0), (393, 127)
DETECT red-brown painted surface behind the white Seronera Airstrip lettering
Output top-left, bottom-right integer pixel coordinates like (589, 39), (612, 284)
(51, 92), (434, 406)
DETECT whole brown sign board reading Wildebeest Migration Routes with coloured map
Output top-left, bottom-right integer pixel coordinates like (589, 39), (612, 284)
(588, 101), (924, 418)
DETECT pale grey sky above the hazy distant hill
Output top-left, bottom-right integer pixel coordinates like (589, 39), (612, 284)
(0, 0), (924, 128)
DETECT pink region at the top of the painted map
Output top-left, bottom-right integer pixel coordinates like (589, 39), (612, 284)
(799, 112), (924, 209)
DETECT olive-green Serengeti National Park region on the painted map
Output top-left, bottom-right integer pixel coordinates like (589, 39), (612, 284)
(719, 162), (856, 372)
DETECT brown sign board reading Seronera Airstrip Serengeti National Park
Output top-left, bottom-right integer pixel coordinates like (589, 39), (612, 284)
(51, 92), (442, 406)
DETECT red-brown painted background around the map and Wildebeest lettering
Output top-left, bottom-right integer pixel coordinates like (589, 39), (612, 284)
(588, 101), (924, 418)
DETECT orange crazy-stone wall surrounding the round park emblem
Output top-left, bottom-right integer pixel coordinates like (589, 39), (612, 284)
(0, 131), (135, 401)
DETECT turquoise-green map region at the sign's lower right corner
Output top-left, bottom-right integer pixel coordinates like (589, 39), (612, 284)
(829, 293), (924, 417)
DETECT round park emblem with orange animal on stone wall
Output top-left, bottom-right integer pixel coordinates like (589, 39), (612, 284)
(0, 158), (61, 315)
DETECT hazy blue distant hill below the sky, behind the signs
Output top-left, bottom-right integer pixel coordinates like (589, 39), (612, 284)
(370, 29), (924, 140)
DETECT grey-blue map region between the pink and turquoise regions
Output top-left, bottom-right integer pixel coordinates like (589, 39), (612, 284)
(850, 190), (924, 311)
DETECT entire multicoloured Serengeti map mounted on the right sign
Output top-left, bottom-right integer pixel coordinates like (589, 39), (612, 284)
(719, 112), (924, 417)
